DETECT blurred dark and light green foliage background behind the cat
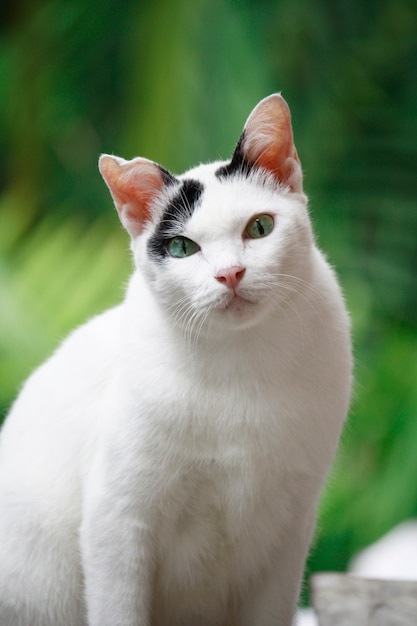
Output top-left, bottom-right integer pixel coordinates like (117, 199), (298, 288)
(0, 0), (417, 604)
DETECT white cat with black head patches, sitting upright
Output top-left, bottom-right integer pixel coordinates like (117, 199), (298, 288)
(0, 94), (352, 626)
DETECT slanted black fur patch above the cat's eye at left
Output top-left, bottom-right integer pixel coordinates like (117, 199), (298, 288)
(148, 178), (204, 260)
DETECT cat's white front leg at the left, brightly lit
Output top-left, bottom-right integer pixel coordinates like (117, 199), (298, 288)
(81, 458), (154, 626)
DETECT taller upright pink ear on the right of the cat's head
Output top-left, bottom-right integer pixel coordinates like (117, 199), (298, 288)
(236, 93), (303, 192)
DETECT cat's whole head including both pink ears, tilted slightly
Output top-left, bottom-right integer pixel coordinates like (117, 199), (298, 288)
(100, 94), (312, 330)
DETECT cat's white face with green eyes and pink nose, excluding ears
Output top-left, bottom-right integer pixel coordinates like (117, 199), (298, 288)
(138, 164), (311, 332)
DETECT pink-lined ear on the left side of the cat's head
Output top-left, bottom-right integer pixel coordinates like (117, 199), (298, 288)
(99, 154), (168, 238)
